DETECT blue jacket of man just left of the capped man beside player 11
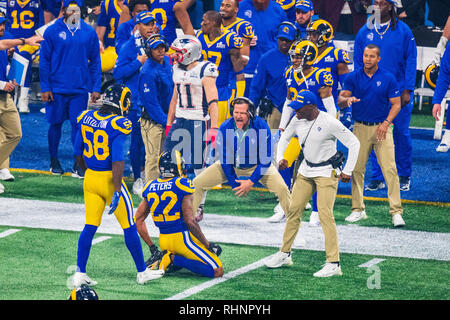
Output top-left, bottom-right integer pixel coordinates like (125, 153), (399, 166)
(113, 36), (142, 110)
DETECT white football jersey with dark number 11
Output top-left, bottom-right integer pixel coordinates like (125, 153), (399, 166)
(173, 61), (219, 120)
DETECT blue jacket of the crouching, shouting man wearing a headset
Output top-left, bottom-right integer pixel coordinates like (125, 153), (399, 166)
(216, 116), (272, 188)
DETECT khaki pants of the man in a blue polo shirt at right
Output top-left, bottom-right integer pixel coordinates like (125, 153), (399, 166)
(352, 123), (403, 215)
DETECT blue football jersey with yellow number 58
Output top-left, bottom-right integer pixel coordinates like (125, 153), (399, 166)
(77, 110), (132, 171)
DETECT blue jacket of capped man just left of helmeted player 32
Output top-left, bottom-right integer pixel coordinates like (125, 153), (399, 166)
(249, 48), (290, 112)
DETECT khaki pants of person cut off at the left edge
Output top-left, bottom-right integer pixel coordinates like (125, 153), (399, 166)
(0, 93), (22, 164)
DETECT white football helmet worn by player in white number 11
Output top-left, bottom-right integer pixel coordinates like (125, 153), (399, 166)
(170, 35), (202, 66)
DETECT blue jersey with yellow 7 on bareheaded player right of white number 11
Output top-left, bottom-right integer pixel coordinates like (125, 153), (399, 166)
(197, 30), (243, 88)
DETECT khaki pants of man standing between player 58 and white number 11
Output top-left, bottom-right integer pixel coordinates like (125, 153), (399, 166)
(141, 118), (166, 183)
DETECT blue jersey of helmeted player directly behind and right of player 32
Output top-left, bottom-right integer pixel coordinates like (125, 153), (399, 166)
(314, 46), (350, 104)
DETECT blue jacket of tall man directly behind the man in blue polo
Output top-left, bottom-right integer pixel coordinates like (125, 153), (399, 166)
(353, 20), (417, 91)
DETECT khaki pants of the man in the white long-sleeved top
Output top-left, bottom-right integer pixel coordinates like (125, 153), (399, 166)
(281, 171), (339, 262)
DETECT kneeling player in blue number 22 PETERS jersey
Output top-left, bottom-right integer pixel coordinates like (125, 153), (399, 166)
(136, 150), (224, 279)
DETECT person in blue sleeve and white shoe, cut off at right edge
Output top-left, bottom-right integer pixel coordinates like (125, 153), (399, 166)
(432, 41), (450, 152)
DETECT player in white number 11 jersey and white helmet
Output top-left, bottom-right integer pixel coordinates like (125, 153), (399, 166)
(164, 35), (219, 217)
